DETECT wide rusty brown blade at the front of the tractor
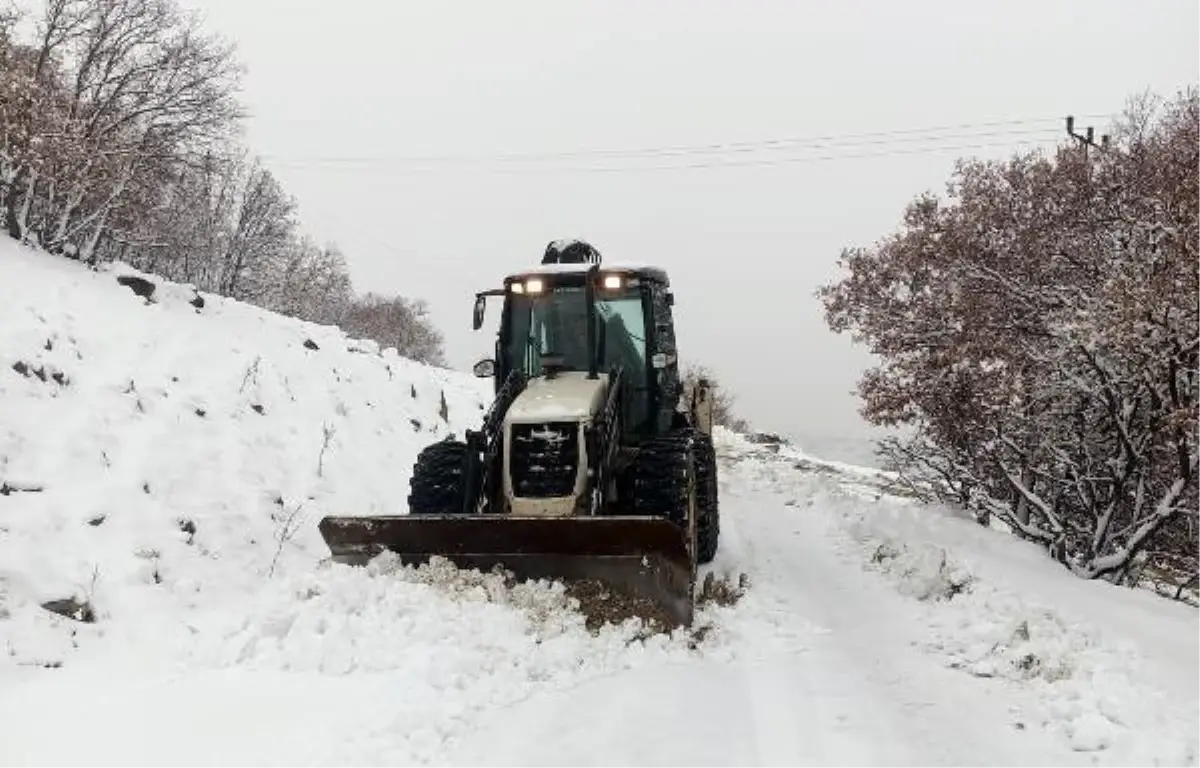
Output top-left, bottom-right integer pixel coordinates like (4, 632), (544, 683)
(318, 515), (695, 626)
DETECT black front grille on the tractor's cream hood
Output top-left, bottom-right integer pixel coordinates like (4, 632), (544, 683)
(511, 421), (580, 499)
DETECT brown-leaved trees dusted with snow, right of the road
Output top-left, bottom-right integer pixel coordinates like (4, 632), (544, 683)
(818, 84), (1200, 581)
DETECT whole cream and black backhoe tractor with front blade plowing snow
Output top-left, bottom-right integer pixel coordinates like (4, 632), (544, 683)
(319, 240), (720, 625)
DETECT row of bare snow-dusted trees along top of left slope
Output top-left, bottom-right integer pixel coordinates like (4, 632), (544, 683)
(0, 0), (444, 365)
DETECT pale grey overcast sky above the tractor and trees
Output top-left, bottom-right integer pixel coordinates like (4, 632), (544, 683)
(174, 0), (1200, 446)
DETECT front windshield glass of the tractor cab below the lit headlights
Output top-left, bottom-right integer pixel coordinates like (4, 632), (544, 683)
(506, 286), (646, 383)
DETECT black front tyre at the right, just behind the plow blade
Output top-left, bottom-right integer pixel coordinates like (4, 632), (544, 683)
(631, 430), (698, 552)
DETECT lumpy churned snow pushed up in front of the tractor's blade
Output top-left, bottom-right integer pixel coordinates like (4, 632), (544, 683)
(174, 554), (803, 766)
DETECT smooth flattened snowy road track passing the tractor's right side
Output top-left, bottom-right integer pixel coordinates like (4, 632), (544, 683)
(444, 451), (1086, 768)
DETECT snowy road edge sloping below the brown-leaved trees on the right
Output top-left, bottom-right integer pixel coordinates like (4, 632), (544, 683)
(740, 434), (1200, 766)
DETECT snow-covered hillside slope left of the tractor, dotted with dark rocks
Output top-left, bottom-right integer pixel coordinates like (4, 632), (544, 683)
(0, 244), (487, 666)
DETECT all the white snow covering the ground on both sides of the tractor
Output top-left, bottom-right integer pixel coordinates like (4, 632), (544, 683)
(0, 242), (1200, 768)
